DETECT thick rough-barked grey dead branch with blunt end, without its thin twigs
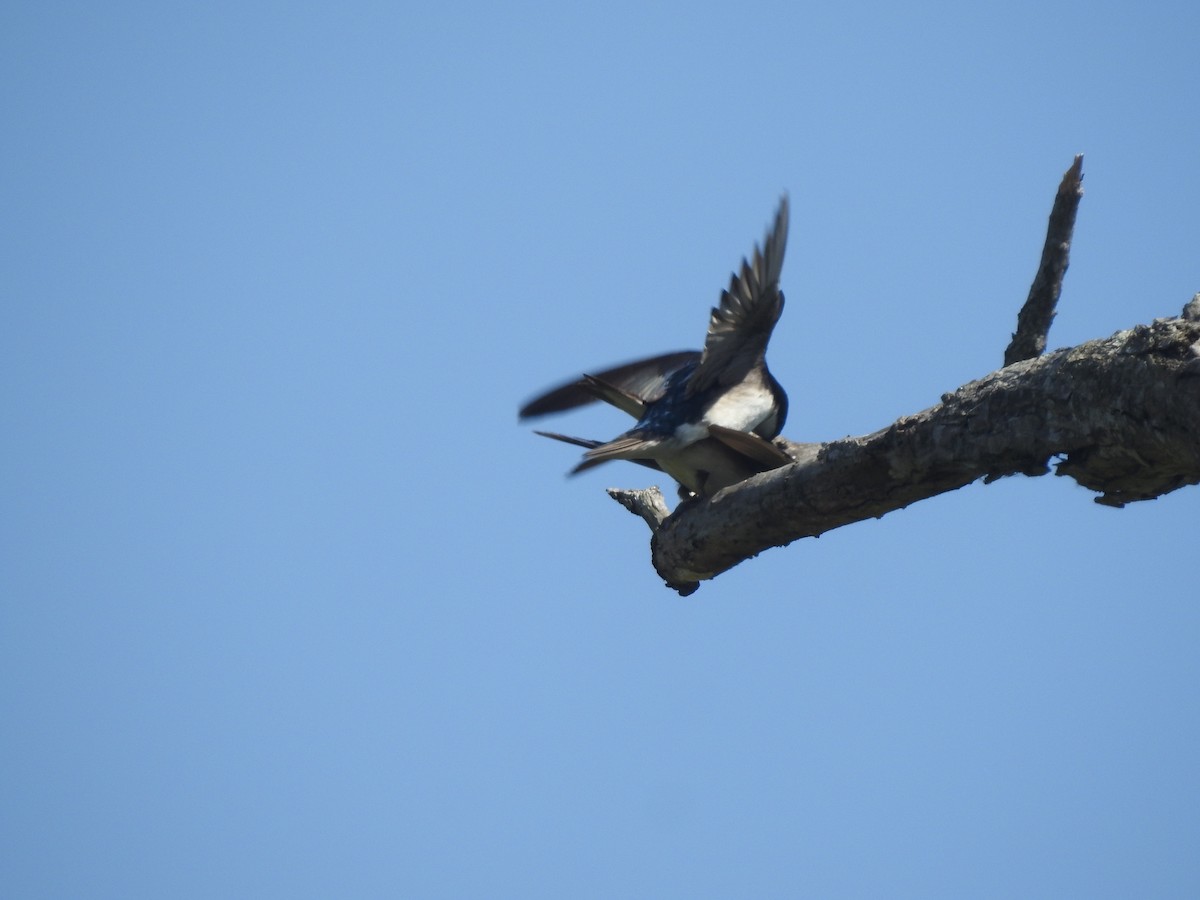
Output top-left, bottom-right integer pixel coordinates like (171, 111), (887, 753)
(652, 318), (1200, 595)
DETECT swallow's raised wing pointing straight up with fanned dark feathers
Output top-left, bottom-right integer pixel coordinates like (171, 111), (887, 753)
(688, 196), (787, 395)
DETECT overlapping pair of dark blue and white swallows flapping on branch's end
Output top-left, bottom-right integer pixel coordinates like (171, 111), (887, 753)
(520, 194), (791, 496)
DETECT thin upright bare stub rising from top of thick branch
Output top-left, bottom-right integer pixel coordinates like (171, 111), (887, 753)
(1004, 154), (1084, 366)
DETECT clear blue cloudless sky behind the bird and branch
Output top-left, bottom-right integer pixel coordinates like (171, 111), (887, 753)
(0, 2), (1200, 899)
